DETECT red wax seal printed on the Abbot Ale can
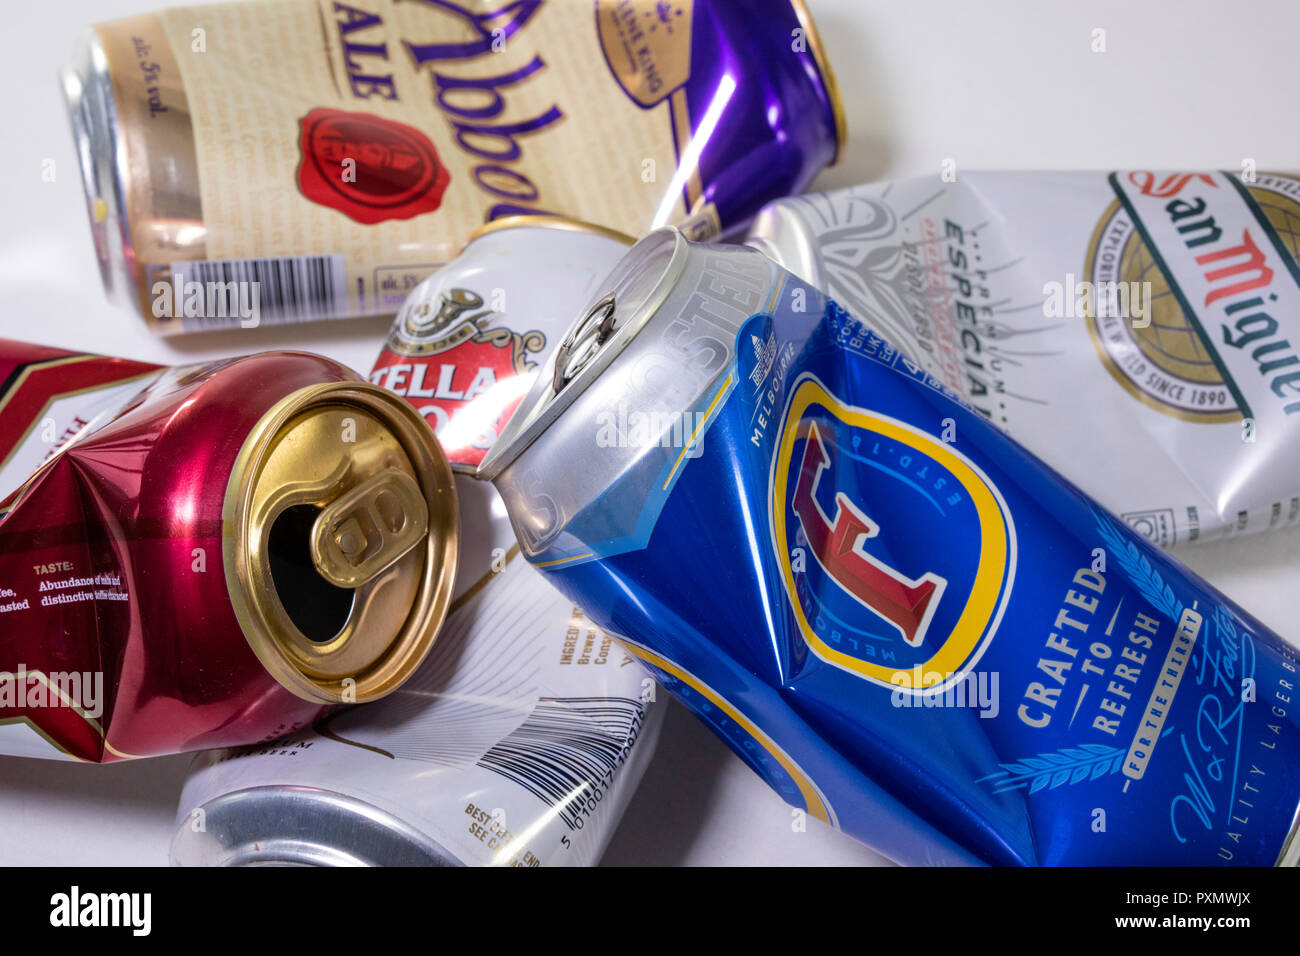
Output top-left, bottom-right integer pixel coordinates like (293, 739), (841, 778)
(298, 107), (451, 225)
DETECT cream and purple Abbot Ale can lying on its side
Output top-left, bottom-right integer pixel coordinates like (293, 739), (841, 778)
(62, 0), (844, 334)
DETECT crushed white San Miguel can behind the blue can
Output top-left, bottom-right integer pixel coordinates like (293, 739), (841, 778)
(750, 170), (1300, 548)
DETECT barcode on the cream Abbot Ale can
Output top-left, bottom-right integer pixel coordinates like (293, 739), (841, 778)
(170, 254), (347, 329)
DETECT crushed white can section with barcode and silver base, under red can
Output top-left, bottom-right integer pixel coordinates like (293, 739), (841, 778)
(172, 477), (664, 866)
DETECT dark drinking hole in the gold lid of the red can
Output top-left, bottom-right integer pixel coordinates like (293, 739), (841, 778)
(267, 505), (356, 644)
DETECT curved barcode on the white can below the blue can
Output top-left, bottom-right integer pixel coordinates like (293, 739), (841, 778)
(478, 697), (645, 830)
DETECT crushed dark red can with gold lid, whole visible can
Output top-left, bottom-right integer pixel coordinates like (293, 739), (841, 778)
(0, 341), (459, 762)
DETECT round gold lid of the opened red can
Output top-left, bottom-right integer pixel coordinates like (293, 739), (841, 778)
(222, 381), (460, 704)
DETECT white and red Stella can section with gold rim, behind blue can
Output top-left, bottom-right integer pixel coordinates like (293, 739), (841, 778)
(371, 216), (636, 473)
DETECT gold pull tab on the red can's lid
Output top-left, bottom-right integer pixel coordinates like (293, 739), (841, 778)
(312, 468), (429, 588)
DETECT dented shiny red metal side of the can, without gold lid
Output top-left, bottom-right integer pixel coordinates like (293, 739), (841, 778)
(0, 341), (356, 761)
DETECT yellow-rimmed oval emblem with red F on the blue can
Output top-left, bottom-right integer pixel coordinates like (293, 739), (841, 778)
(768, 375), (1017, 692)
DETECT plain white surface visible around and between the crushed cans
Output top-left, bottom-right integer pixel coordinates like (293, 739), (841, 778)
(0, 0), (1300, 865)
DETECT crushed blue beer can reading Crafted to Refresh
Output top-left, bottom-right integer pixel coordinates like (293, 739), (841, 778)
(481, 229), (1300, 865)
